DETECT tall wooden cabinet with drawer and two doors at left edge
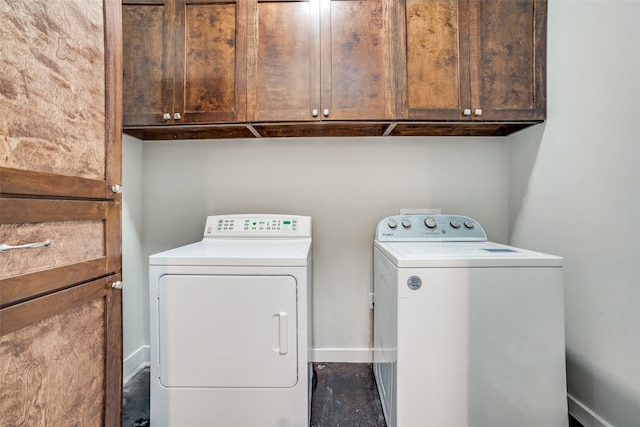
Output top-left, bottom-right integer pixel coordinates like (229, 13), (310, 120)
(0, 0), (122, 427)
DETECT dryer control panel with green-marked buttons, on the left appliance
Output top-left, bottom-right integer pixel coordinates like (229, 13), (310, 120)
(204, 214), (311, 238)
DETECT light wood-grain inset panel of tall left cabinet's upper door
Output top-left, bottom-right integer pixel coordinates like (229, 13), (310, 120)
(0, 0), (106, 179)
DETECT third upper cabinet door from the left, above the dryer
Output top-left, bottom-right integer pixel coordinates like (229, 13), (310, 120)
(247, 0), (320, 121)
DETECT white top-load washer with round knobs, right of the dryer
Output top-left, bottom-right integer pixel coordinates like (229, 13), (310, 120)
(373, 215), (568, 427)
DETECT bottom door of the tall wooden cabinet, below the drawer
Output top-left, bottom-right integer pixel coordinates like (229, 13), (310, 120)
(0, 276), (122, 427)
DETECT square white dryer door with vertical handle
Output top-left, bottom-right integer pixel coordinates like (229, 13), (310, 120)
(158, 275), (298, 388)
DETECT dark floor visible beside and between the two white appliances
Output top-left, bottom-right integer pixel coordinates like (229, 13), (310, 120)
(123, 363), (583, 427)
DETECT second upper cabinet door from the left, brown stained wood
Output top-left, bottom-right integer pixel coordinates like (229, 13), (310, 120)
(176, 0), (247, 124)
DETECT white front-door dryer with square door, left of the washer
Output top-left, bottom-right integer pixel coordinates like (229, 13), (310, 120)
(149, 215), (312, 427)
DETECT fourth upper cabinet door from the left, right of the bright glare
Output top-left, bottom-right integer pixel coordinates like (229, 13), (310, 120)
(320, 0), (394, 120)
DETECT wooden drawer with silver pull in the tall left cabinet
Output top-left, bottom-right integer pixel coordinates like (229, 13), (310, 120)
(0, 199), (120, 306)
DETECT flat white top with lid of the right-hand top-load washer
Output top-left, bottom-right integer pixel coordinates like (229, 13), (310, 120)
(374, 240), (562, 267)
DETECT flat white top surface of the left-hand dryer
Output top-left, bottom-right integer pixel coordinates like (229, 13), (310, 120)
(149, 238), (311, 266)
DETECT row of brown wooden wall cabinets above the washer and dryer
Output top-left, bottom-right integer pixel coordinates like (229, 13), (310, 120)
(123, 0), (547, 139)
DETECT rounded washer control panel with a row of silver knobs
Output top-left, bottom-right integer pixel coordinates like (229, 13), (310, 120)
(375, 214), (487, 242)
